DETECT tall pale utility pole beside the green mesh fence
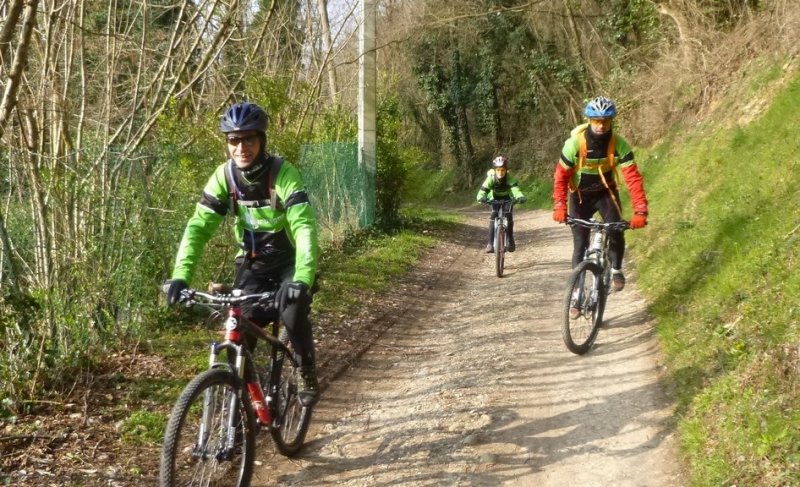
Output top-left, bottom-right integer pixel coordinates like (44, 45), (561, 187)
(358, 0), (377, 227)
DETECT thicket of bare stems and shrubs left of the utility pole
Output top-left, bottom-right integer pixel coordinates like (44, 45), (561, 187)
(0, 0), (360, 406)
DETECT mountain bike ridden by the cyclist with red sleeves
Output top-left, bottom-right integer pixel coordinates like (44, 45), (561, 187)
(561, 217), (629, 355)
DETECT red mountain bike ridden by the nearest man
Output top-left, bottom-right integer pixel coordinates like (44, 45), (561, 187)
(160, 286), (311, 487)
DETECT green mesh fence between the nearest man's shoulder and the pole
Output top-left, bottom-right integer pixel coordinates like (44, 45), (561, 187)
(299, 142), (375, 240)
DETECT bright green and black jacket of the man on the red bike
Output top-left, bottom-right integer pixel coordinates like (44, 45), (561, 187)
(172, 157), (319, 287)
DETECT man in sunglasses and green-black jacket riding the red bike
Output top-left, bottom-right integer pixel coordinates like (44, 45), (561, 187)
(167, 102), (319, 406)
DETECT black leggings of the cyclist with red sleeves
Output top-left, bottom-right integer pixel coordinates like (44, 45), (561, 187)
(569, 188), (625, 269)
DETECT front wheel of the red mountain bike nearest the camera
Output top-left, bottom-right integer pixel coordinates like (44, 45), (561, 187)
(160, 369), (256, 487)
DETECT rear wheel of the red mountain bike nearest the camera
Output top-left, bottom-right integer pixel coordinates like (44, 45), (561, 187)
(269, 328), (311, 457)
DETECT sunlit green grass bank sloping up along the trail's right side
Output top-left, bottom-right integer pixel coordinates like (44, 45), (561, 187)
(630, 67), (800, 486)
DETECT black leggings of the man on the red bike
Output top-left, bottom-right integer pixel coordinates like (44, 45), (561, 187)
(236, 257), (314, 365)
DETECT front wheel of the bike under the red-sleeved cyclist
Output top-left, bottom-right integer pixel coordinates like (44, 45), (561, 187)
(561, 261), (605, 355)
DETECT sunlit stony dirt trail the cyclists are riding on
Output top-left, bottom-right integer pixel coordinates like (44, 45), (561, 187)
(253, 208), (687, 487)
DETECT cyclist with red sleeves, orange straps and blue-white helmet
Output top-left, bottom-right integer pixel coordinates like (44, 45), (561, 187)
(553, 96), (647, 291)
